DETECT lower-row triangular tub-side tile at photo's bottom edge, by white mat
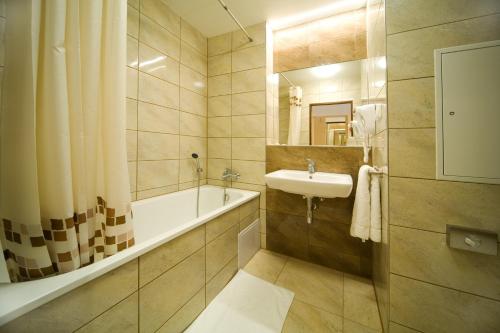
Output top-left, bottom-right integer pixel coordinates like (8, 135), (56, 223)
(157, 287), (205, 333)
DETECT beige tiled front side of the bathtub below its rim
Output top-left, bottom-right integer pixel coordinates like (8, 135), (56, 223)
(0, 199), (259, 333)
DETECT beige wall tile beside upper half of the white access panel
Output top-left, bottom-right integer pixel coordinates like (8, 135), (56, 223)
(388, 78), (435, 128)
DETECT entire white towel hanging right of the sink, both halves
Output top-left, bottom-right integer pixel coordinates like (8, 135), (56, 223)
(350, 165), (381, 242)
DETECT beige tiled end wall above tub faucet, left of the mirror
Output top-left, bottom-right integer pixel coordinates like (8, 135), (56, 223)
(207, 23), (266, 247)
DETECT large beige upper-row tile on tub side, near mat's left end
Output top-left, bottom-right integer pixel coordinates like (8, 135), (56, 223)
(139, 248), (205, 332)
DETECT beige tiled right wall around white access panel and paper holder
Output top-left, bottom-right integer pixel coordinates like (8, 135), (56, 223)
(386, 0), (500, 332)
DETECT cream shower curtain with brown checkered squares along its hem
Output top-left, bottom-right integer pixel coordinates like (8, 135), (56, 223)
(0, 0), (134, 281)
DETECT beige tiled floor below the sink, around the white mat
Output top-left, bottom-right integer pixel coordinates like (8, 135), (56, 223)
(245, 250), (382, 333)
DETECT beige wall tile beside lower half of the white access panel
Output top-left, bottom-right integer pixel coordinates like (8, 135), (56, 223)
(389, 128), (436, 179)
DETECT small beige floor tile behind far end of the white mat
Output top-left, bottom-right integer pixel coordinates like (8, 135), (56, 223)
(245, 250), (287, 283)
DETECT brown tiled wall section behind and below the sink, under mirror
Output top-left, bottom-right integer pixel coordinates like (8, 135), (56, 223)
(266, 146), (371, 276)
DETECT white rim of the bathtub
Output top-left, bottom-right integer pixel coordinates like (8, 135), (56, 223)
(0, 185), (260, 327)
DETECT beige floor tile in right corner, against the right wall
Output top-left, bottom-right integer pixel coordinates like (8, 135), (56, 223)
(344, 274), (382, 331)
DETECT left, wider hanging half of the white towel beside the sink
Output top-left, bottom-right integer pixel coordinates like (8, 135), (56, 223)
(351, 165), (373, 240)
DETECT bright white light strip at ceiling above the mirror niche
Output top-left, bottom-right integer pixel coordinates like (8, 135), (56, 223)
(269, 0), (366, 30)
